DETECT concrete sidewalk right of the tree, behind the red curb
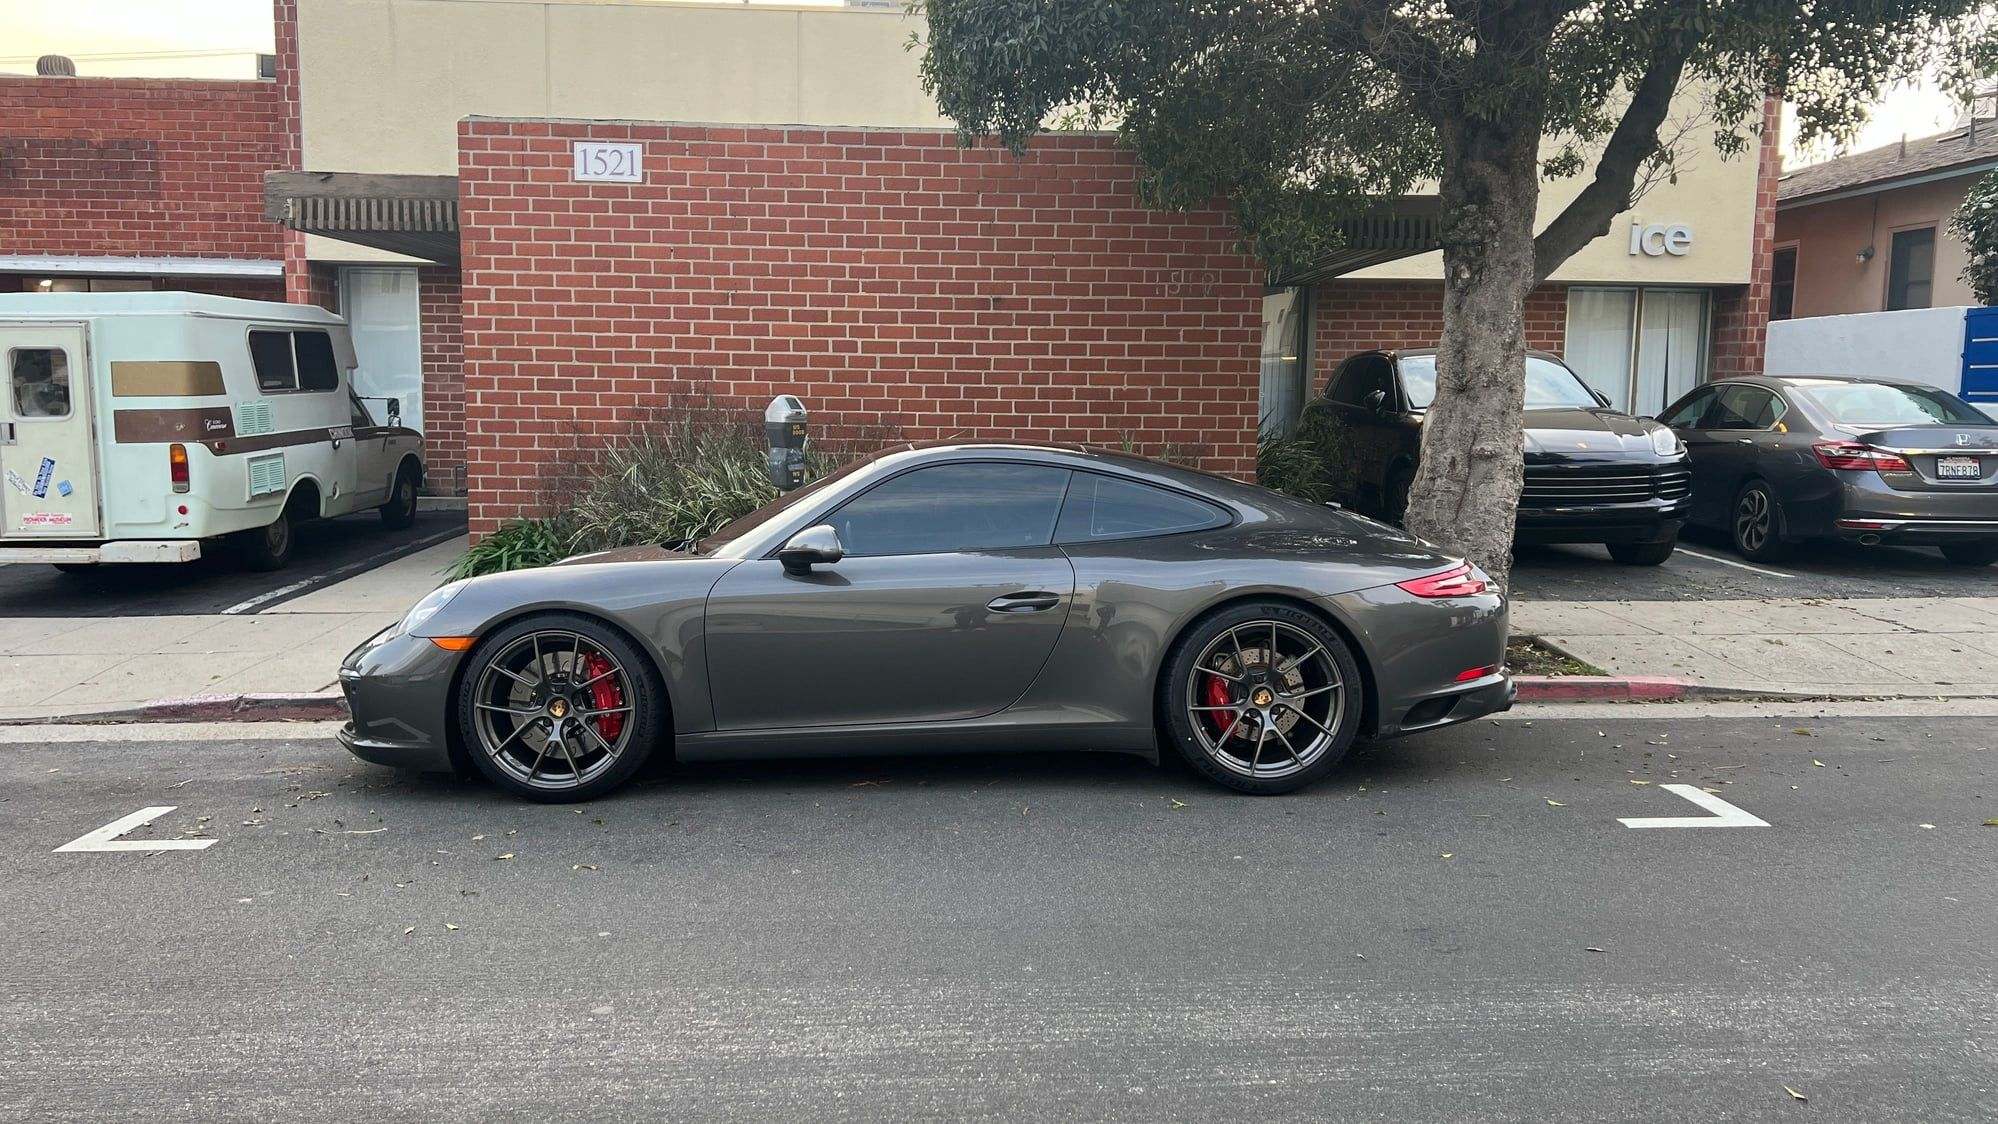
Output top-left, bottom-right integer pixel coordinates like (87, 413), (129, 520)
(1512, 597), (1998, 697)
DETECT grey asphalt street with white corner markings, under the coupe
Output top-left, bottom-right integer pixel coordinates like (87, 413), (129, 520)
(0, 709), (1998, 1120)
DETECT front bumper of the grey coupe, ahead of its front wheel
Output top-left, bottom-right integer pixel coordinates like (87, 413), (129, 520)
(336, 625), (462, 773)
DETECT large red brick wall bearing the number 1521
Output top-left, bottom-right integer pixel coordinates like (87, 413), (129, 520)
(460, 118), (1263, 533)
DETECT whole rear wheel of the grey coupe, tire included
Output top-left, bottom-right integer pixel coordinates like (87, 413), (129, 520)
(1157, 601), (1365, 797)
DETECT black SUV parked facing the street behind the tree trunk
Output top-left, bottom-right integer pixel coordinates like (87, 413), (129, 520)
(1321, 347), (1692, 565)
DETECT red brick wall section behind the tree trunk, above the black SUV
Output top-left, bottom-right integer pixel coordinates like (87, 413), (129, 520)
(1311, 281), (1568, 373)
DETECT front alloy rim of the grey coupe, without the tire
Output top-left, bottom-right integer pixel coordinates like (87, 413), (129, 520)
(472, 629), (637, 789)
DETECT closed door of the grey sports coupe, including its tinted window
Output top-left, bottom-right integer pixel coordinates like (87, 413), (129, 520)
(707, 461), (1075, 731)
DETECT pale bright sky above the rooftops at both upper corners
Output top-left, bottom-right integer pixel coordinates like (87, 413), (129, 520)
(0, 0), (1960, 168)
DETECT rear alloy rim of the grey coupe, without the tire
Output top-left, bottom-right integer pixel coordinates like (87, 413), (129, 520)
(1187, 621), (1347, 779)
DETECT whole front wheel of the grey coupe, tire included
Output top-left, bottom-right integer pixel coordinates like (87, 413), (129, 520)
(458, 613), (665, 803)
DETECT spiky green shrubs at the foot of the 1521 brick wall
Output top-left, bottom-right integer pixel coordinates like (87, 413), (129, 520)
(450, 403), (891, 577)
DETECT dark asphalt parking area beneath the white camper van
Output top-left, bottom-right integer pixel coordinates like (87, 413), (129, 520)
(0, 511), (466, 617)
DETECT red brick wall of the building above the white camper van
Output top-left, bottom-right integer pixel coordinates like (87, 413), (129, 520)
(0, 76), (288, 260)
